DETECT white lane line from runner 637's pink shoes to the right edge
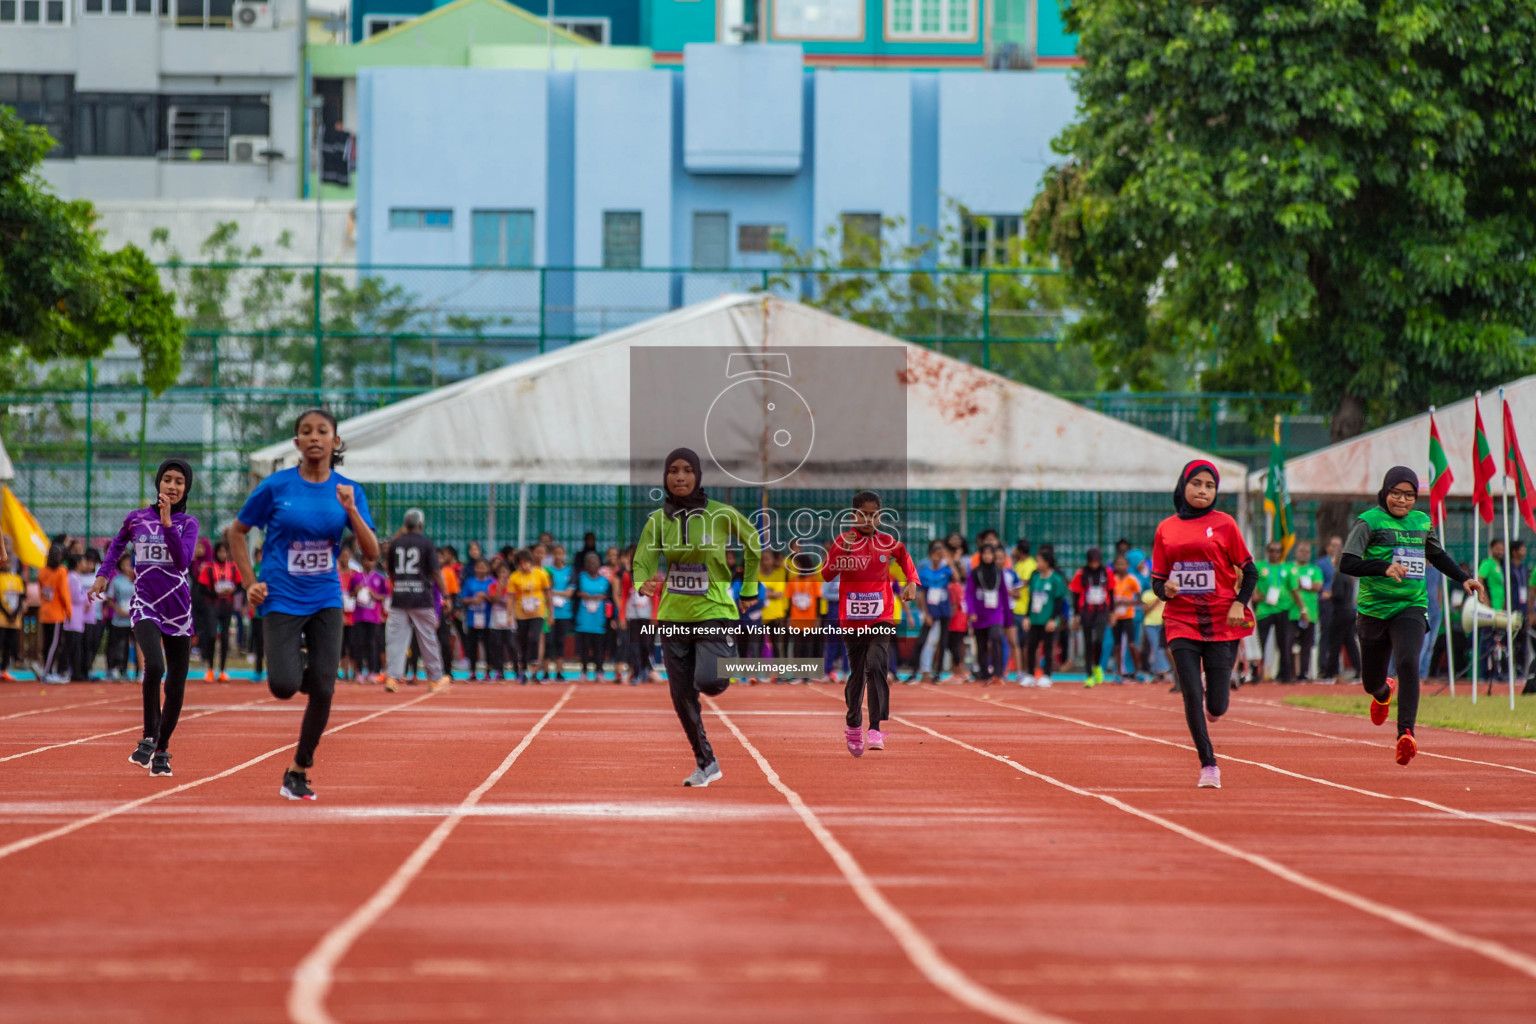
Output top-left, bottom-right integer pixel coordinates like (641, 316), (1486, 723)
(892, 715), (1536, 978)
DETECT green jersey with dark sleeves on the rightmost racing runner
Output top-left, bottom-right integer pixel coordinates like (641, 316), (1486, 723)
(1344, 507), (1462, 619)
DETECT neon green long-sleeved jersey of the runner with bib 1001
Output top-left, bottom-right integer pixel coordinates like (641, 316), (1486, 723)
(634, 500), (762, 622)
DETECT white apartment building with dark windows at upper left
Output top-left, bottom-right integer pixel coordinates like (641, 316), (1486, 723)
(0, 0), (307, 200)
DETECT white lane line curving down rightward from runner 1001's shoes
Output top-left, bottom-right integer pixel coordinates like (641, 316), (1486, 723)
(703, 697), (1066, 1024)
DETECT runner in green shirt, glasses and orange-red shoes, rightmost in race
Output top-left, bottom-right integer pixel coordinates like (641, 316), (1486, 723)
(1339, 465), (1488, 765)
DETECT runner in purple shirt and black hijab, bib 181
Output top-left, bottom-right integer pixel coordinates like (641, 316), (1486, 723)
(91, 459), (197, 775)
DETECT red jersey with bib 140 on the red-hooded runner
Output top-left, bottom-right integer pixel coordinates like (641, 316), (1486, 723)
(1152, 511), (1253, 640)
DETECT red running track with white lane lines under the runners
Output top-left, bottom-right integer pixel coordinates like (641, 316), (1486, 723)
(0, 683), (1536, 1024)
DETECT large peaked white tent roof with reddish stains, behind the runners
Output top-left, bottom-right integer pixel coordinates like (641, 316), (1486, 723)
(250, 295), (1244, 491)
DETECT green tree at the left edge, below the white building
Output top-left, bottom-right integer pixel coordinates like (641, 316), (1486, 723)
(0, 107), (183, 393)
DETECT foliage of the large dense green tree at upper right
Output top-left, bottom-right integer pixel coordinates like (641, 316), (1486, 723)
(1029, 0), (1536, 439)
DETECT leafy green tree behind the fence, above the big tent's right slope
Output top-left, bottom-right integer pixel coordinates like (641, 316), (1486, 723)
(770, 204), (1098, 391)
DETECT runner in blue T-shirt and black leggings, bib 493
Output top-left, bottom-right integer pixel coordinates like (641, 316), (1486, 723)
(226, 408), (379, 800)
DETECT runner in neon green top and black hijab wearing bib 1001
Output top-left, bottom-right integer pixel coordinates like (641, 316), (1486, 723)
(634, 448), (762, 786)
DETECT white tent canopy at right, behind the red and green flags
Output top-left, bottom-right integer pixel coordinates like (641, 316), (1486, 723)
(1249, 376), (1536, 499)
